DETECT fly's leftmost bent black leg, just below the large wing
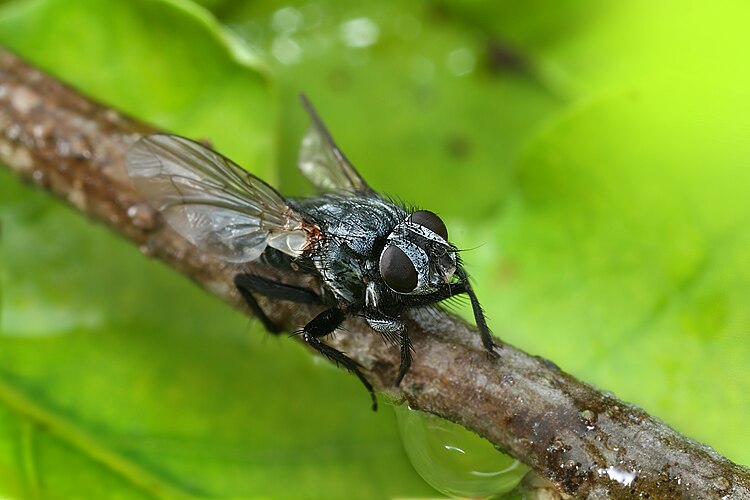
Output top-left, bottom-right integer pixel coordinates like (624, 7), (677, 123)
(234, 274), (322, 334)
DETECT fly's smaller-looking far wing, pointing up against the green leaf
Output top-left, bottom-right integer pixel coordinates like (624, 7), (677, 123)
(299, 95), (372, 192)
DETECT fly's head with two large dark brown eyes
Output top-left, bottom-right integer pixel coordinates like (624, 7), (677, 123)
(379, 210), (459, 295)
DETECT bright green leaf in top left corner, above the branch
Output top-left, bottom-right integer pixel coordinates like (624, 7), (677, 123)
(0, 0), (277, 170)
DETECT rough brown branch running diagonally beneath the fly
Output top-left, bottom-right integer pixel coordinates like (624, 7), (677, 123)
(0, 50), (750, 498)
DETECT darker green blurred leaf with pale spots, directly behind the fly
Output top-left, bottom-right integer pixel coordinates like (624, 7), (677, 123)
(221, 1), (565, 219)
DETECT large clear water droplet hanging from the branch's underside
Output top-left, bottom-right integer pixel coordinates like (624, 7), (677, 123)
(395, 405), (528, 498)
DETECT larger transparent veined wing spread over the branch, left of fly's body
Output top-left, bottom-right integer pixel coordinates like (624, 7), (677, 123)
(125, 134), (312, 263)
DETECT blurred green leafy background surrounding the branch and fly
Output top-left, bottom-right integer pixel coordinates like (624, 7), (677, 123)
(0, 0), (750, 498)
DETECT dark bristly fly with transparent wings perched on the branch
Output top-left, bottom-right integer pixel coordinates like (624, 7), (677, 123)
(126, 96), (497, 410)
